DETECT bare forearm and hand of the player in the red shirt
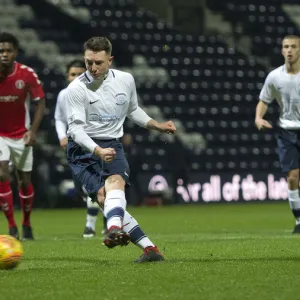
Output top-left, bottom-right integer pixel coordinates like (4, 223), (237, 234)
(24, 99), (46, 146)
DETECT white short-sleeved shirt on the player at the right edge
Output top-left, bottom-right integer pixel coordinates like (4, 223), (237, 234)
(259, 65), (300, 129)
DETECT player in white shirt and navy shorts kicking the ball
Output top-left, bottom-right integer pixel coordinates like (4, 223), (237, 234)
(67, 37), (176, 262)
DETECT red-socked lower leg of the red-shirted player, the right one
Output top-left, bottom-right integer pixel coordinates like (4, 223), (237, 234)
(19, 183), (34, 240)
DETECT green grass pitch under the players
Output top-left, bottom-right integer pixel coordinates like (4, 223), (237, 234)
(0, 202), (300, 300)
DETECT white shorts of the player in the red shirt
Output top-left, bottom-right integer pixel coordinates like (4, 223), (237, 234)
(0, 136), (33, 172)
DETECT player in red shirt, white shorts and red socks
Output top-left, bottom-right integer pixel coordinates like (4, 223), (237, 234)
(0, 32), (45, 240)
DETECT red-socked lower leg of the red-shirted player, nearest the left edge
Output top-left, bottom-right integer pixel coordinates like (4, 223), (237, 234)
(0, 181), (19, 239)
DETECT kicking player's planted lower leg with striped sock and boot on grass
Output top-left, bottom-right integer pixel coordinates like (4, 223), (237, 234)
(123, 211), (165, 263)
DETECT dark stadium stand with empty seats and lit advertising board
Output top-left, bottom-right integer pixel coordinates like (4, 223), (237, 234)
(4, 0), (299, 207)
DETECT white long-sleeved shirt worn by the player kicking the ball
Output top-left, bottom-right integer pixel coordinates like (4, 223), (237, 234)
(66, 69), (151, 152)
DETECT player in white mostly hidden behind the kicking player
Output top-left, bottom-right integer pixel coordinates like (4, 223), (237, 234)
(54, 60), (106, 238)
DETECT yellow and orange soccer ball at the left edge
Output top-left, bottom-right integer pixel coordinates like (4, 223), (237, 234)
(0, 235), (23, 270)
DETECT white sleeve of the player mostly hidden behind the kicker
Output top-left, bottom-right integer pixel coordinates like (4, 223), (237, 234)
(54, 91), (68, 140)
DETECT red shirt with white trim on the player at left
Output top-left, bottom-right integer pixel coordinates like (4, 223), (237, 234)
(0, 62), (45, 138)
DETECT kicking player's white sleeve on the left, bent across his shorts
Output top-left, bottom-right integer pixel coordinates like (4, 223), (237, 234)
(66, 87), (98, 153)
